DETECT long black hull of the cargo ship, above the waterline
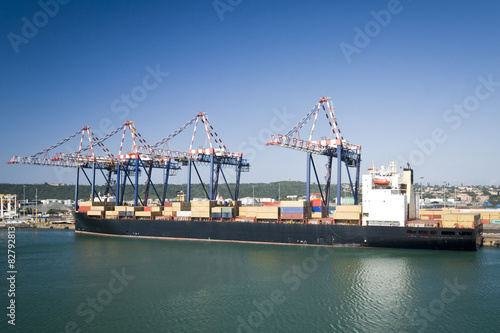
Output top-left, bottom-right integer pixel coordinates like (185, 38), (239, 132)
(75, 213), (482, 251)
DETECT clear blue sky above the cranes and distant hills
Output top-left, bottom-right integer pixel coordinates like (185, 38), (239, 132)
(0, 0), (500, 185)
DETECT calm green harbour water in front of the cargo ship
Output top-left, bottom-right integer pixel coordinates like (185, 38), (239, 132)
(0, 230), (500, 332)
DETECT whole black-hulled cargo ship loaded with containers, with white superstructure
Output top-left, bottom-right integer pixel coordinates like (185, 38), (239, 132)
(75, 163), (482, 251)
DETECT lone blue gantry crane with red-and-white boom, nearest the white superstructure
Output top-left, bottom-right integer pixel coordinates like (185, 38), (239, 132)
(267, 97), (361, 207)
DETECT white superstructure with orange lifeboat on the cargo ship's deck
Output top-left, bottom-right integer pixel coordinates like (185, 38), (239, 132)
(362, 162), (419, 227)
